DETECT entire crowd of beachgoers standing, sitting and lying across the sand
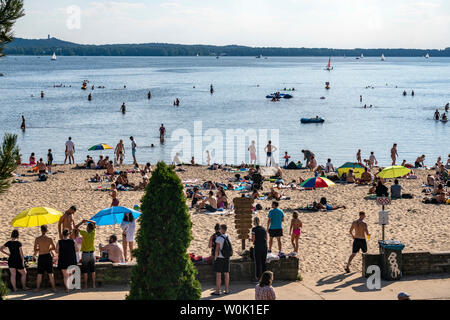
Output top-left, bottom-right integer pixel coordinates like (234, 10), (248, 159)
(4, 114), (450, 299)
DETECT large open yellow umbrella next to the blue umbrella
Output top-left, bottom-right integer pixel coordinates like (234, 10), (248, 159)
(11, 207), (63, 228)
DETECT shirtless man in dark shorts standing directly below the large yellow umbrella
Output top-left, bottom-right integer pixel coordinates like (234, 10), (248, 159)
(34, 225), (56, 292)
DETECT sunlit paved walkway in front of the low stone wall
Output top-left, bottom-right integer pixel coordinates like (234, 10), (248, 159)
(4, 273), (450, 300)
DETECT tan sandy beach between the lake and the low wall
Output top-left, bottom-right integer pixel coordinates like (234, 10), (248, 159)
(0, 165), (450, 278)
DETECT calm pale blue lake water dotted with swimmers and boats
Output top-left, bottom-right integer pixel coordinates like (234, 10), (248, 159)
(0, 56), (450, 165)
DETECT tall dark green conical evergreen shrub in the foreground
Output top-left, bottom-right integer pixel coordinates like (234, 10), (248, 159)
(127, 162), (201, 300)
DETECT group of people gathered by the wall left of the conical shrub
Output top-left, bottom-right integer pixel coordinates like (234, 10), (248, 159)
(0, 206), (136, 293)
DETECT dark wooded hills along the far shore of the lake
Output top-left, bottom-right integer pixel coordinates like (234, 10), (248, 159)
(4, 38), (450, 57)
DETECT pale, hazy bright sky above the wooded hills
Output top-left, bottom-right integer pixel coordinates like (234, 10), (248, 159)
(16, 0), (450, 49)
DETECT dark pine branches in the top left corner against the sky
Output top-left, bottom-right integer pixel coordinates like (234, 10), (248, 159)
(0, 0), (25, 56)
